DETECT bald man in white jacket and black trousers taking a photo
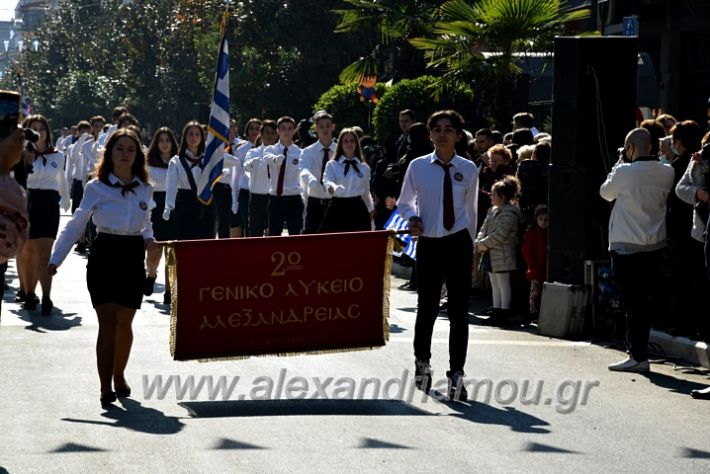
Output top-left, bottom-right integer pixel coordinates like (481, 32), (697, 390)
(599, 128), (674, 373)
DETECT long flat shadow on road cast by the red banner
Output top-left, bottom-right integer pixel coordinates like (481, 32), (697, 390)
(178, 400), (431, 418)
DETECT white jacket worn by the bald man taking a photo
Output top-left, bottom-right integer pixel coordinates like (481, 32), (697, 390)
(599, 159), (674, 250)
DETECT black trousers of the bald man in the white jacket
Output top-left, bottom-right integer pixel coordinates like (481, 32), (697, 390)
(611, 249), (668, 362)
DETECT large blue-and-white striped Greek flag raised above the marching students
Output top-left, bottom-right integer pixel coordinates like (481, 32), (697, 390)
(197, 14), (229, 204)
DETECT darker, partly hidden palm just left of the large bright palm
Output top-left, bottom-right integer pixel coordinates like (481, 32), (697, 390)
(333, 0), (440, 84)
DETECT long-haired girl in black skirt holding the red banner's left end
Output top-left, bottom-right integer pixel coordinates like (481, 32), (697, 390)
(48, 129), (155, 406)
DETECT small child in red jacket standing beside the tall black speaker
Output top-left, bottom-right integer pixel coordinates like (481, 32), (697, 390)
(521, 204), (549, 319)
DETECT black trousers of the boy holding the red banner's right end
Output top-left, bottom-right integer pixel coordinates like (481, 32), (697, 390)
(414, 230), (473, 372)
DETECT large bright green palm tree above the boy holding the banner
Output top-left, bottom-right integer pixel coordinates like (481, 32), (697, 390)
(410, 0), (589, 125)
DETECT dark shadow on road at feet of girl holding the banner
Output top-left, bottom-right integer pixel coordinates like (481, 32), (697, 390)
(62, 398), (185, 435)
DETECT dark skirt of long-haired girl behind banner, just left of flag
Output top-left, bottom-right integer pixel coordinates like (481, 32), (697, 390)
(173, 189), (216, 240)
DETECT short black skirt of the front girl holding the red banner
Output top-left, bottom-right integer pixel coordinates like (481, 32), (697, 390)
(86, 233), (145, 309)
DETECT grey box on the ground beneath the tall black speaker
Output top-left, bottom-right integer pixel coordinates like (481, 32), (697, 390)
(538, 282), (589, 339)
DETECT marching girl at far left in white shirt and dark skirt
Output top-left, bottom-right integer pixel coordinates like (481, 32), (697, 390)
(16, 115), (69, 316)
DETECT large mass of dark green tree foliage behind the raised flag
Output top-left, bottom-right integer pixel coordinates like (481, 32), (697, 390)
(0, 0), (372, 133)
